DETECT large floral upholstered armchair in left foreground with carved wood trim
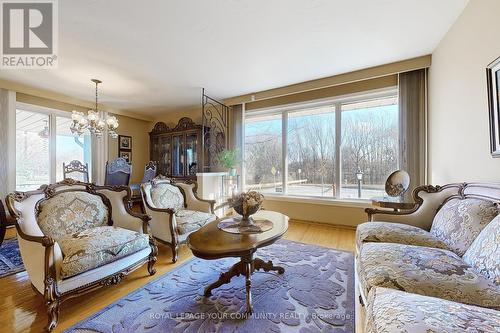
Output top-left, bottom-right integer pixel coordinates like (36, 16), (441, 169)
(7, 179), (158, 331)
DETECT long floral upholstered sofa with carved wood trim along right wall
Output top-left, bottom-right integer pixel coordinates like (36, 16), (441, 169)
(356, 183), (500, 332)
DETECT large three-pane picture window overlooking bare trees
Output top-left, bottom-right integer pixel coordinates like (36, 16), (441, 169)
(244, 89), (399, 199)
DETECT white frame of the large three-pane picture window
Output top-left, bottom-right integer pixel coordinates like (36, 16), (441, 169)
(242, 86), (400, 204)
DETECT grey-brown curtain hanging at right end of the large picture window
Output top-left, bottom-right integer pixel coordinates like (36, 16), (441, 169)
(398, 69), (427, 194)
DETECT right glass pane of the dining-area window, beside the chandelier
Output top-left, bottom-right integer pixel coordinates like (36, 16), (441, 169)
(55, 117), (92, 181)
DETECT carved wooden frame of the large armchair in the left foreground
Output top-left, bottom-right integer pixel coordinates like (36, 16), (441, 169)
(7, 179), (158, 331)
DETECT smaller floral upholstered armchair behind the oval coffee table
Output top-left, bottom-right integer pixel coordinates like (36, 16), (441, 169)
(141, 179), (217, 262)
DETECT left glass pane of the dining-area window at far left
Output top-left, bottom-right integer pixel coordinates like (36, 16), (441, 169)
(16, 109), (50, 191)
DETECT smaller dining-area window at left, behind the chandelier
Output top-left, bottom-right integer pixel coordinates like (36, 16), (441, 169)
(16, 103), (91, 191)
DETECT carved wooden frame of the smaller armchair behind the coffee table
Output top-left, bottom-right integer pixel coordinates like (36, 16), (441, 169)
(141, 177), (215, 263)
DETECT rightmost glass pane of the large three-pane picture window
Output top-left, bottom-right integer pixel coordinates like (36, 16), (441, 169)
(341, 96), (399, 199)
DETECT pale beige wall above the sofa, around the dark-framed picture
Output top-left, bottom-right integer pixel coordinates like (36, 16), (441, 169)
(429, 0), (500, 184)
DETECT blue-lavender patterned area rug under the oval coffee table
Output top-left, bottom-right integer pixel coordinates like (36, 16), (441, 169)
(65, 240), (355, 333)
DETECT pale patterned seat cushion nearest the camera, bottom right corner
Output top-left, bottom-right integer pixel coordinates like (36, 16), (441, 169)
(365, 288), (500, 333)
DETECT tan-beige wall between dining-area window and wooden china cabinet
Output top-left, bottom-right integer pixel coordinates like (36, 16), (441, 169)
(108, 115), (153, 183)
